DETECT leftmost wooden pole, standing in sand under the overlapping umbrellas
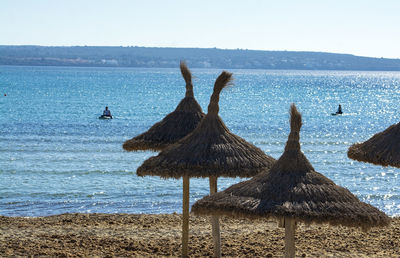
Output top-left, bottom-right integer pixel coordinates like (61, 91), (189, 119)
(182, 176), (189, 257)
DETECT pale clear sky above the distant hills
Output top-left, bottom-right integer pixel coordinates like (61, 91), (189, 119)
(0, 0), (400, 58)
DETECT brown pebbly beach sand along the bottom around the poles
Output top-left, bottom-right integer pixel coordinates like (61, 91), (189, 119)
(0, 214), (400, 257)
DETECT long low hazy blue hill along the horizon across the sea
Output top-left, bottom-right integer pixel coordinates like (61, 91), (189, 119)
(0, 46), (400, 71)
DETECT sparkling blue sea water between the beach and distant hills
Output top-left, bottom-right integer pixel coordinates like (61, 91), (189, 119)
(0, 66), (400, 216)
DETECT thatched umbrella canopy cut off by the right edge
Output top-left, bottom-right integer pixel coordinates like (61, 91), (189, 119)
(347, 123), (400, 168)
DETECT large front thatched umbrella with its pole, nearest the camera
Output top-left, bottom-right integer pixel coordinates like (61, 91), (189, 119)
(192, 105), (390, 257)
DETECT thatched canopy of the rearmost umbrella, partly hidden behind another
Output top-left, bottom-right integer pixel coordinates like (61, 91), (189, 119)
(122, 61), (204, 151)
